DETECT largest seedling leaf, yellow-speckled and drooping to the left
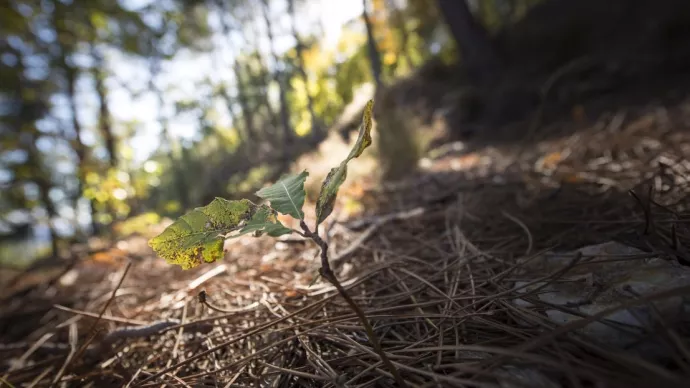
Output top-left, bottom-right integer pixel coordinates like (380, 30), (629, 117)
(149, 198), (292, 269)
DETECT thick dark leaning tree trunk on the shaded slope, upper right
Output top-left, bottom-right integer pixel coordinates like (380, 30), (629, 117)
(438, 0), (502, 82)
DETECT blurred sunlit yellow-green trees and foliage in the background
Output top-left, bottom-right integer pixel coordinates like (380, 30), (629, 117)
(0, 0), (536, 262)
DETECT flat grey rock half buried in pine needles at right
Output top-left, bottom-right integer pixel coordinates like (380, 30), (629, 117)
(515, 242), (690, 357)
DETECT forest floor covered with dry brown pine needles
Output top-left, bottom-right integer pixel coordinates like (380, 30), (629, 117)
(0, 55), (690, 388)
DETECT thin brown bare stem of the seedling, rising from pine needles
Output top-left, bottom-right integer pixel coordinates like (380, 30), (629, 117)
(300, 220), (407, 387)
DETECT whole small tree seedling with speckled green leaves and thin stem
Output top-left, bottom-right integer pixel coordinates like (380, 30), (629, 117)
(149, 100), (407, 387)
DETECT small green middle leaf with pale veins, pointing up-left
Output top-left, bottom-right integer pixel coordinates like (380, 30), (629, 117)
(256, 171), (309, 220)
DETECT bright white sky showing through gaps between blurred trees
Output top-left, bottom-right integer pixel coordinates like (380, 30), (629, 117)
(106, 0), (362, 162)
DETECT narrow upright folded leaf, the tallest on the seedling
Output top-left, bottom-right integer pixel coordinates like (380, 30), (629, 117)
(316, 100), (374, 226)
